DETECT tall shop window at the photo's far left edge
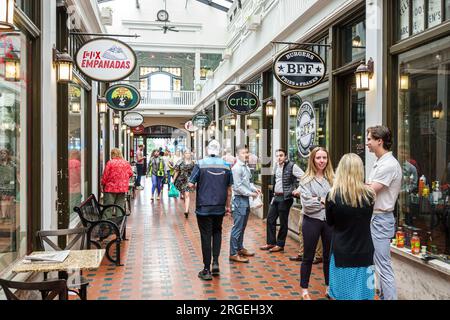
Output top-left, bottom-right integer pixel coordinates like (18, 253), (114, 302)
(0, 33), (29, 272)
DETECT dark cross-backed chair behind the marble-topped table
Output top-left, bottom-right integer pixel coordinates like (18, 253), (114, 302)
(37, 227), (89, 300)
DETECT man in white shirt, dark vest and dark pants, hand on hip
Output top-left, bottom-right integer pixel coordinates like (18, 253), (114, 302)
(260, 149), (304, 252)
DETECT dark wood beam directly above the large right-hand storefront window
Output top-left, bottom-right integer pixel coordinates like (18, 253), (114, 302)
(389, 20), (450, 55)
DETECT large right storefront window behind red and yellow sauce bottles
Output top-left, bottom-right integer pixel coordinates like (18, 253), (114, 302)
(398, 37), (450, 254)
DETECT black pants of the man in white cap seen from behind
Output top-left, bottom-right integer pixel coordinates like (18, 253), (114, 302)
(197, 215), (224, 270)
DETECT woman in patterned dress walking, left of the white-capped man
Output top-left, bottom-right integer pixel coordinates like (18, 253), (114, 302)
(173, 150), (195, 218)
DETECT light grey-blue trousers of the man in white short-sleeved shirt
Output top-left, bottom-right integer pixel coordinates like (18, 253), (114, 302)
(370, 213), (397, 300)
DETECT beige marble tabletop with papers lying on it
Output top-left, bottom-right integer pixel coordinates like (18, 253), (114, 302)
(12, 249), (105, 273)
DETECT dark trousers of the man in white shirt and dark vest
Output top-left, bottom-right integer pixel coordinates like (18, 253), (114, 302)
(267, 196), (294, 247)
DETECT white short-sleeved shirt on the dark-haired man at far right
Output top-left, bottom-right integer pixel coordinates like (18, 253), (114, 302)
(369, 152), (403, 213)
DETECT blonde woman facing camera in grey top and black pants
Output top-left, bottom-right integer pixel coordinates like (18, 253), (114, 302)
(294, 147), (334, 300)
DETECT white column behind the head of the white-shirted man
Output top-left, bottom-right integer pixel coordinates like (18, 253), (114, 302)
(366, 0), (386, 179)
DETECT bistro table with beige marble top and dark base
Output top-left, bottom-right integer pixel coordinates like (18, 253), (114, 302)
(12, 249), (106, 300)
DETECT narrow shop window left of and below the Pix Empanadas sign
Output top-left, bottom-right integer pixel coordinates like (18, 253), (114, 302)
(68, 84), (87, 219)
